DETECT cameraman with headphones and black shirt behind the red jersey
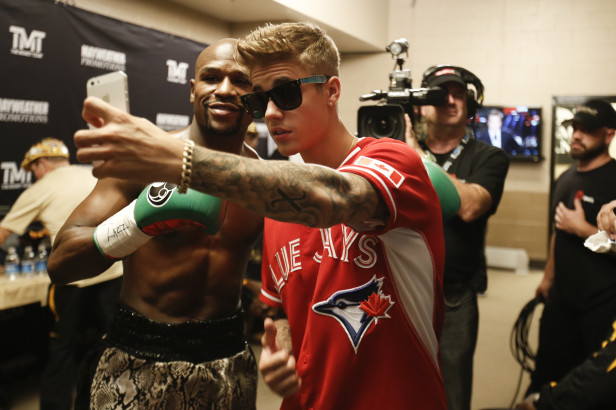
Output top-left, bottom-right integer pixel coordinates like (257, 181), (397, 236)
(405, 66), (509, 410)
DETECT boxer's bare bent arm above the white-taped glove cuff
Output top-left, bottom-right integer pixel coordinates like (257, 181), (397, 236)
(47, 179), (142, 284)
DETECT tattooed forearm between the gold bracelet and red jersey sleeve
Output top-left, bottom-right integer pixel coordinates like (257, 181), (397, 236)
(191, 147), (386, 227)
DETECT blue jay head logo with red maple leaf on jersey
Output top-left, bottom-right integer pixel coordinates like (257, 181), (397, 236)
(312, 275), (395, 353)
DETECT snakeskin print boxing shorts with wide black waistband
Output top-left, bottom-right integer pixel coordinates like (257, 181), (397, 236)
(75, 306), (257, 410)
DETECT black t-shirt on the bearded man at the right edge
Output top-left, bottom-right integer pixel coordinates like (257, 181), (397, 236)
(551, 160), (616, 310)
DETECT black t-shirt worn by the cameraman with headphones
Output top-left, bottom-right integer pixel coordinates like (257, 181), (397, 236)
(424, 138), (509, 292)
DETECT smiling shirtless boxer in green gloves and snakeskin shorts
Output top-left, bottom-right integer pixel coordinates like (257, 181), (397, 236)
(49, 39), (263, 409)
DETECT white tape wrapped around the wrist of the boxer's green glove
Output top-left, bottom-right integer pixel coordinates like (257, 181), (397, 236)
(94, 200), (152, 260)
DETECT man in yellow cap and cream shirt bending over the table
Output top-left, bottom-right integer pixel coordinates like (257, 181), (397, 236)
(0, 138), (122, 409)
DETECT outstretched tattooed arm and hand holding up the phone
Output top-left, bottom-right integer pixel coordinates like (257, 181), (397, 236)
(75, 98), (387, 227)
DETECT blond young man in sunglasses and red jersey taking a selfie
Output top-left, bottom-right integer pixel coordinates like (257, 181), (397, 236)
(65, 23), (445, 409)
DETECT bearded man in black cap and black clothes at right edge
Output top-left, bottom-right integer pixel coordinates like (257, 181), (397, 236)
(527, 100), (616, 394)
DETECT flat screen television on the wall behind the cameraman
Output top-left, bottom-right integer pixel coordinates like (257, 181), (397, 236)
(473, 105), (542, 162)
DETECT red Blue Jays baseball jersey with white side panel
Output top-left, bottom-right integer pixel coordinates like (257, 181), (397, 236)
(260, 138), (446, 410)
